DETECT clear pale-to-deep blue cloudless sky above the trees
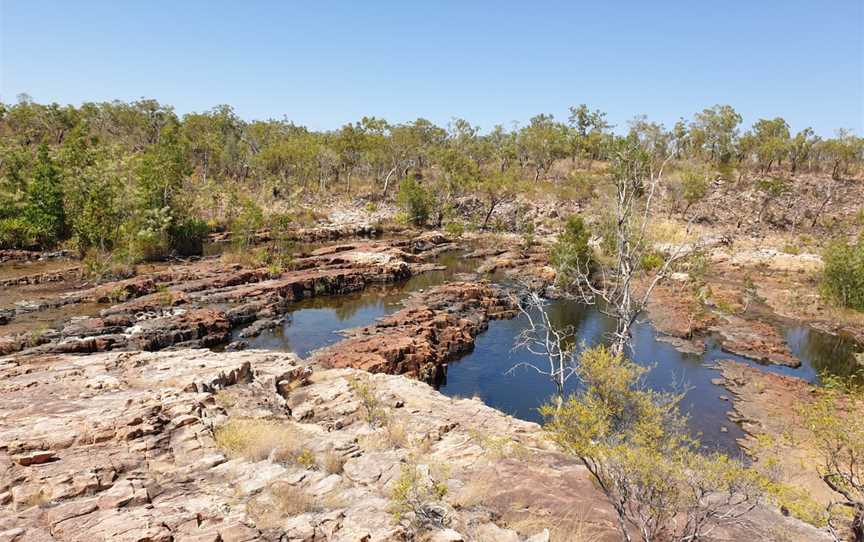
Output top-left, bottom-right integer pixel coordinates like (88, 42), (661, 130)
(0, 0), (864, 135)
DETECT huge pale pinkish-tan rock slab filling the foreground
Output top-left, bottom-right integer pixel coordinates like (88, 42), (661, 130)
(0, 350), (823, 542)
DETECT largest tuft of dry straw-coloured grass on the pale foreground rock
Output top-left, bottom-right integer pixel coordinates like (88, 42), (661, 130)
(215, 418), (303, 461)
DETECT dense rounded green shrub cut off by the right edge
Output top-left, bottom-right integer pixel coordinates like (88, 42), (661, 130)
(822, 235), (864, 311)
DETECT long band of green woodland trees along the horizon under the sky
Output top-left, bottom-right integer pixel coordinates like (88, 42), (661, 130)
(0, 97), (864, 258)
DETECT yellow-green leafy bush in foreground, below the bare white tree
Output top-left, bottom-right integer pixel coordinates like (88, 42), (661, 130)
(541, 346), (765, 542)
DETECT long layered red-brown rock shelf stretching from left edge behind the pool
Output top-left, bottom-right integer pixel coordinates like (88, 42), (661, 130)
(0, 237), (454, 355)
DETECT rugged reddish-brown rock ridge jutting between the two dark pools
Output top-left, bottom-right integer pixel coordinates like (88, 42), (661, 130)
(313, 282), (516, 382)
